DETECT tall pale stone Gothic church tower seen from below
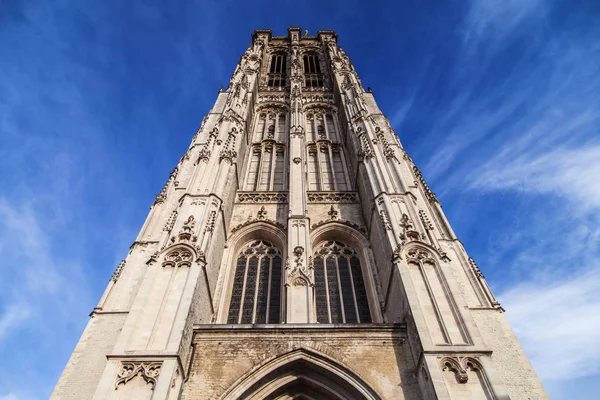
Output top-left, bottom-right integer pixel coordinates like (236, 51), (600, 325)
(52, 28), (547, 400)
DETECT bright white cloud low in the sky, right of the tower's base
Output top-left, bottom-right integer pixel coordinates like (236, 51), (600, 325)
(498, 266), (600, 381)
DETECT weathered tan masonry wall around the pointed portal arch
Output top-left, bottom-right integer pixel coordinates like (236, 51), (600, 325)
(182, 324), (423, 400)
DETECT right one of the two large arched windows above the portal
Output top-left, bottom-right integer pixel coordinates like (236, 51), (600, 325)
(313, 241), (371, 324)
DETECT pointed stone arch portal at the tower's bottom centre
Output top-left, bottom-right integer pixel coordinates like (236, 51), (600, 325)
(221, 349), (380, 400)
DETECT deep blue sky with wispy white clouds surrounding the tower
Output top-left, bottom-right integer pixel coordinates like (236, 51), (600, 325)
(0, 0), (600, 400)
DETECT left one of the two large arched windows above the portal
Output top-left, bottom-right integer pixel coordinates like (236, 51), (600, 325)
(227, 240), (282, 324)
